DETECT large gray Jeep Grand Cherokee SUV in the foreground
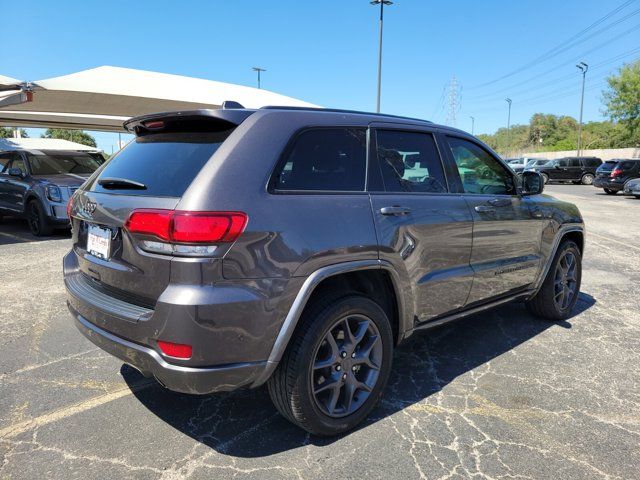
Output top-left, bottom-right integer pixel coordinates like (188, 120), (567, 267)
(64, 107), (584, 435)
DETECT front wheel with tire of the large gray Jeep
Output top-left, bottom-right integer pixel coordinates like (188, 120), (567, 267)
(527, 240), (582, 321)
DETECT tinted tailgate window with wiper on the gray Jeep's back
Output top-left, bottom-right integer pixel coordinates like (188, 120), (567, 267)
(89, 130), (232, 197)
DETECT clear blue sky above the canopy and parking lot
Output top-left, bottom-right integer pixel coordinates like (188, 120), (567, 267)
(0, 0), (640, 152)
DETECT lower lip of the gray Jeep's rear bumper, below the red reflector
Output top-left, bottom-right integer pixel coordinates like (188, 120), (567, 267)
(68, 304), (266, 394)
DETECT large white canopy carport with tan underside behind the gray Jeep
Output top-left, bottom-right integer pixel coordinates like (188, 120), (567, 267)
(0, 66), (317, 131)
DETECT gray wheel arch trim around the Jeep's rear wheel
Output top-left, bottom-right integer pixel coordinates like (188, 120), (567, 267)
(252, 260), (410, 387)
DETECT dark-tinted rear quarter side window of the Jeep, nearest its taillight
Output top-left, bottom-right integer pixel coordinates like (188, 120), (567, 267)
(273, 128), (367, 192)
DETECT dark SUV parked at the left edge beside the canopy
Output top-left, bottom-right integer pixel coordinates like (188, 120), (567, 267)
(0, 150), (102, 236)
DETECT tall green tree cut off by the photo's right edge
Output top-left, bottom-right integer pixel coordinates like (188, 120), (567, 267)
(603, 60), (640, 144)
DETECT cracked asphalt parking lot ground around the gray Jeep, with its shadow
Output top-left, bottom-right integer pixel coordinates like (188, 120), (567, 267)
(0, 185), (640, 479)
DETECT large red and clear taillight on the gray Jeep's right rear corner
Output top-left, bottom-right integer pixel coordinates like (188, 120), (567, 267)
(124, 209), (248, 256)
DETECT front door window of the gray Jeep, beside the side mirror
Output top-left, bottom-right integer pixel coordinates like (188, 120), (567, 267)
(447, 137), (516, 195)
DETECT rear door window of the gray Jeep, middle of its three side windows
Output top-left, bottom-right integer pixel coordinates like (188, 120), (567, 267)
(376, 130), (447, 193)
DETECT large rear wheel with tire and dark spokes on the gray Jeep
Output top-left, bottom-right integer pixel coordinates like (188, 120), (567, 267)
(267, 293), (393, 436)
